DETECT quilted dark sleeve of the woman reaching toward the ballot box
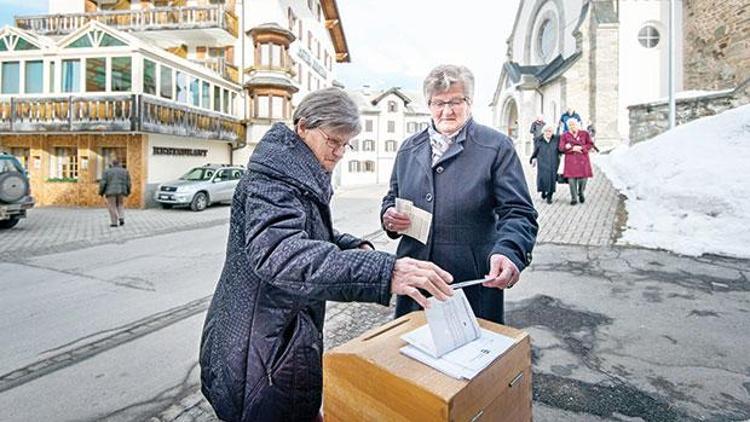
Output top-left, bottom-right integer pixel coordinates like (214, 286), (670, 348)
(245, 185), (395, 305)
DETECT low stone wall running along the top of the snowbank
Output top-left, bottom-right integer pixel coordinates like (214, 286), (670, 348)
(628, 79), (750, 145)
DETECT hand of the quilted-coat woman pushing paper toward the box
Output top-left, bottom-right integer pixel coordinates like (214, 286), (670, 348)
(391, 258), (453, 309)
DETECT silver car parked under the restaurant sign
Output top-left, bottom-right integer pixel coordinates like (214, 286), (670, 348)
(154, 164), (245, 211)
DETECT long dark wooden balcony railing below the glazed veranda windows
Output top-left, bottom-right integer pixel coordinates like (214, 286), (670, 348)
(0, 94), (245, 145)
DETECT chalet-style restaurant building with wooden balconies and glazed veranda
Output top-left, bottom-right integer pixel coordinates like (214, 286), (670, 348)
(0, 0), (349, 207)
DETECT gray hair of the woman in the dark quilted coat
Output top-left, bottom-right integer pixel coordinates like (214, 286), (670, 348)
(292, 88), (362, 135)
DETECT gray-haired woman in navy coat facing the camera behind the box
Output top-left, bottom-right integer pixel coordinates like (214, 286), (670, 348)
(381, 65), (538, 323)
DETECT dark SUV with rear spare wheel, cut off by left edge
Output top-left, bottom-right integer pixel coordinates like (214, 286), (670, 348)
(0, 152), (34, 229)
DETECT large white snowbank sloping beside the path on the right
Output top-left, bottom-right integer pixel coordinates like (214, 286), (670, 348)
(595, 105), (750, 258)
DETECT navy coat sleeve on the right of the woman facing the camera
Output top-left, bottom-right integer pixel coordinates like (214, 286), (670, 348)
(491, 143), (539, 271)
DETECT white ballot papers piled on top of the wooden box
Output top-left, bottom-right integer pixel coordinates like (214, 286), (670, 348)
(400, 290), (514, 379)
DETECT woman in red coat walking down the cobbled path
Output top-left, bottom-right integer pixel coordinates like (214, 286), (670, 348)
(559, 119), (594, 205)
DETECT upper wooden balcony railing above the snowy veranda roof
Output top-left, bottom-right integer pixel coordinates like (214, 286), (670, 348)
(16, 6), (239, 38)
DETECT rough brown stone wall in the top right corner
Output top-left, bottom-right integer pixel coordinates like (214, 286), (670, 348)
(683, 0), (750, 90)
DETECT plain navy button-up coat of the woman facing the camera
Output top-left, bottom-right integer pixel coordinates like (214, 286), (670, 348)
(380, 120), (539, 323)
